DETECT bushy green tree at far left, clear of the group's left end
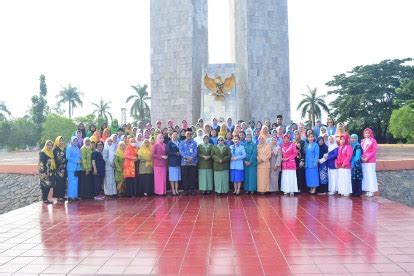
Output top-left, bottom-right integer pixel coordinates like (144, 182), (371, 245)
(7, 116), (39, 150)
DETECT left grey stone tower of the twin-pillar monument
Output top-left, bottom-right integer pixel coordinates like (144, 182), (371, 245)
(150, 0), (208, 123)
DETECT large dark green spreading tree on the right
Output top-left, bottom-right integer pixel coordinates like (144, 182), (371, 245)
(327, 58), (414, 142)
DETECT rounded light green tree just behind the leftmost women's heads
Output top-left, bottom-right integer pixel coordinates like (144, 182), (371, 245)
(41, 113), (76, 145)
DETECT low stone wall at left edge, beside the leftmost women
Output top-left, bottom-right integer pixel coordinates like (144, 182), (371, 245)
(0, 174), (41, 214)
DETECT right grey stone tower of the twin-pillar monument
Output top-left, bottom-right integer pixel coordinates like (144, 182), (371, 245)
(235, 0), (290, 120)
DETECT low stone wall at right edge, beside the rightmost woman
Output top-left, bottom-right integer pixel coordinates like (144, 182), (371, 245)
(378, 170), (414, 206)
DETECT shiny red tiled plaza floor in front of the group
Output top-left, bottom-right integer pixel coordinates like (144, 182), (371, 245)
(0, 195), (414, 275)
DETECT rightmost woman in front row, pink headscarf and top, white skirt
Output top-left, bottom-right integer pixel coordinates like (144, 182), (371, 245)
(361, 128), (378, 197)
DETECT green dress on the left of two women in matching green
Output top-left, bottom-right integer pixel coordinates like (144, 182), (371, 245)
(197, 144), (213, 191)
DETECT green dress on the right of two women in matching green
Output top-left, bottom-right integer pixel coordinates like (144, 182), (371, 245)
(211, 145), (231, 194)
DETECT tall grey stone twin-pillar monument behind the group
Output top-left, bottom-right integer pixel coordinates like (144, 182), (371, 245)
(150, 0), (290, 123)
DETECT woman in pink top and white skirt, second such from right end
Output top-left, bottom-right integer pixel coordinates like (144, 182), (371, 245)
(336, 133), (352, 196)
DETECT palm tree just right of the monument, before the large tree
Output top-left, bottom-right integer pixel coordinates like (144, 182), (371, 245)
(297, 86), (329, 127)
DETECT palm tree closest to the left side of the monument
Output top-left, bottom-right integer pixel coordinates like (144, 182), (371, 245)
(126, 84), (151, 121)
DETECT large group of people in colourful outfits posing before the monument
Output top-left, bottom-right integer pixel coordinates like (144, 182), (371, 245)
(39, 115), (378, 204)
